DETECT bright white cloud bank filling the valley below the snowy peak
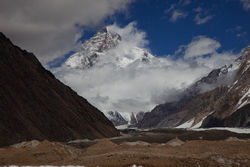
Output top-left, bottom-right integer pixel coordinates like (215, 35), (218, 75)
(53, 22), (238, 118)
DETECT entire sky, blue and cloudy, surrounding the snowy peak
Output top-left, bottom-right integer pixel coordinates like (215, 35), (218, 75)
(0, 0), (250, 117)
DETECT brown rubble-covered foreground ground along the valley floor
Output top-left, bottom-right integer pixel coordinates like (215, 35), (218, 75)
(0, 129), (250, 167)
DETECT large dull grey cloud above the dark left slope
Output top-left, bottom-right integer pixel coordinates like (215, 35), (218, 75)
(0, 0), (132, 64)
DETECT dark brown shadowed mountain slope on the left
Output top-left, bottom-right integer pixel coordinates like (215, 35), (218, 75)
(0, 33), (119, 146)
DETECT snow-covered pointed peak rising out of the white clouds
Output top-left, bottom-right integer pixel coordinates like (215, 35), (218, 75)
(65, 27), (153, 69)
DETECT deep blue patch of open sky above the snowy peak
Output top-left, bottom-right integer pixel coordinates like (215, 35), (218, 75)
(82, 0), (250, 56)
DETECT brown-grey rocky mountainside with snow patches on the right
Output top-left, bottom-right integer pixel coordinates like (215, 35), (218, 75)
(138, 46), (250, 128)
